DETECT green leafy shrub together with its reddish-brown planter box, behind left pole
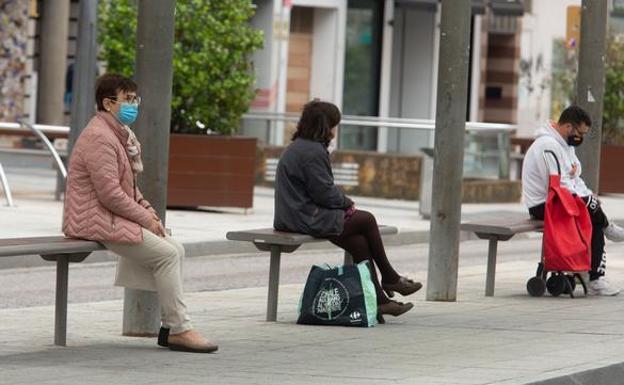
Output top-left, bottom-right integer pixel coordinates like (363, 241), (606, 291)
(99, 0), (263, 208)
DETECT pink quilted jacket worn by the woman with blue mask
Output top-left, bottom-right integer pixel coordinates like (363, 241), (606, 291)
(63, 112), (153, 243)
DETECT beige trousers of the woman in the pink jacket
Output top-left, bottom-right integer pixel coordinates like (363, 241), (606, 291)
(102, 229), (192, 334)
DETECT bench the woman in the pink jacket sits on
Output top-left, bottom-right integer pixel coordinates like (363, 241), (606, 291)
(0, 236), (105, 346)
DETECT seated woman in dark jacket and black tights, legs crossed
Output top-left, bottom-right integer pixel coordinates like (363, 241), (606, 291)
(273, 99), (422, 323)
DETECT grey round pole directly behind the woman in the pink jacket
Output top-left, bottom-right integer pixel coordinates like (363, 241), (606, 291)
(123, 0), (175, 336)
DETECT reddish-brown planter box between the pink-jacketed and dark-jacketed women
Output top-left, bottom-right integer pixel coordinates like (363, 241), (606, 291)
(167, 134), (256, 208)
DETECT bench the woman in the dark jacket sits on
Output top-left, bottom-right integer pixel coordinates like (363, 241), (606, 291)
(225, 226), (398, 321)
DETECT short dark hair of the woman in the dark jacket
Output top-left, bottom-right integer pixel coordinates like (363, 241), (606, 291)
(292, 99), (341, 147)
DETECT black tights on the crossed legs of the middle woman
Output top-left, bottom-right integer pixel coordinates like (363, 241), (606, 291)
(329, 210), (400, 304)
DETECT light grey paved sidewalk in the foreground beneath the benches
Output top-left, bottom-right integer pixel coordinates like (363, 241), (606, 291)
(0, 239), (624, 385)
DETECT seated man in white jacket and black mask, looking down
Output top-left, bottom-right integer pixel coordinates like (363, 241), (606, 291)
(522, 106), (624, 295)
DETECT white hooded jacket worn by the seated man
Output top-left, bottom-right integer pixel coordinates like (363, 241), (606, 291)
(522, 122), (592, 208)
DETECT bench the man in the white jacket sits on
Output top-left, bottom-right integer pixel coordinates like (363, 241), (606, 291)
(460, 215), (544, 297)
